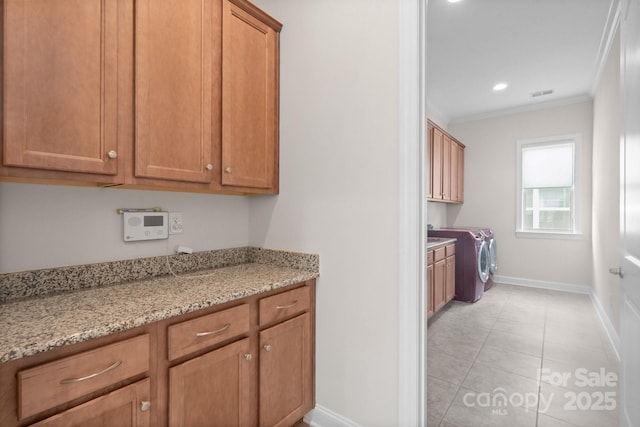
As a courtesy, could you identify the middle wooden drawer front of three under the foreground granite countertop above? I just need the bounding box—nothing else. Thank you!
[168,304,249,360]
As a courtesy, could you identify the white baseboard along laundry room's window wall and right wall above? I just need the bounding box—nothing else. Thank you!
[493,276,620,360]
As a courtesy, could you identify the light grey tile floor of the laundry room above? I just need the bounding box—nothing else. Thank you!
[427,284,619,427]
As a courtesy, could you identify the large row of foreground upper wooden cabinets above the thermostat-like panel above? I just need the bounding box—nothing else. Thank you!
[0,0,282,194]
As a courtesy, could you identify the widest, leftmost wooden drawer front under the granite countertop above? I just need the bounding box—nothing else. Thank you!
[18,334,149,419]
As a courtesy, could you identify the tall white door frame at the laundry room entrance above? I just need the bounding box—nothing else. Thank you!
[398,0,428,426]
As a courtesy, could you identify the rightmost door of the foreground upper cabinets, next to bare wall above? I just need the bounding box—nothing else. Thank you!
[221,0,281,192]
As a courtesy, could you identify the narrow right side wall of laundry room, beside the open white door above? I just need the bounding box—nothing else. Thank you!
[593,30,622,333]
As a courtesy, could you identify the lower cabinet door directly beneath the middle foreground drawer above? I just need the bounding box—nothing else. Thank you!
[169,338,254,427]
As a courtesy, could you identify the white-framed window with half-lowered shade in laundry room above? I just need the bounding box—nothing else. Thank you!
[516,134,581,237]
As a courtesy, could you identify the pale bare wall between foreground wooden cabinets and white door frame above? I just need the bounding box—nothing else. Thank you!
[250,0,399,426]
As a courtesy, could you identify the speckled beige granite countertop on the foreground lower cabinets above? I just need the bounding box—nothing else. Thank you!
[0,248,319,362]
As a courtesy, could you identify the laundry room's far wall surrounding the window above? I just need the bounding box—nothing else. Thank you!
[448,102,593,286]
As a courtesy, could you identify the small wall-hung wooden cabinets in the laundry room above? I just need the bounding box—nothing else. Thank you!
[427,121,464,203]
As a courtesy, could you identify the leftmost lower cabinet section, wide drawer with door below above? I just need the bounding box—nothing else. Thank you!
[0,327,155,427]
